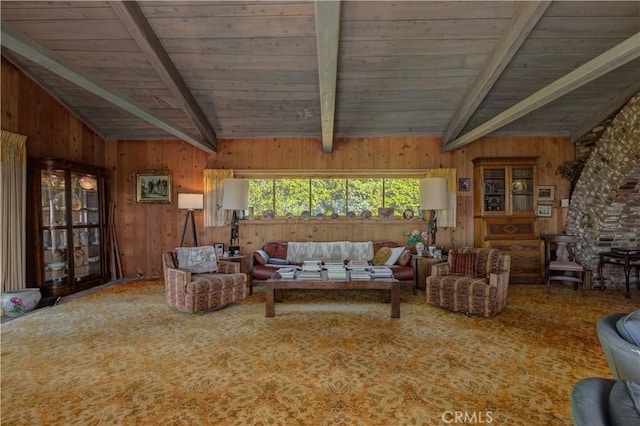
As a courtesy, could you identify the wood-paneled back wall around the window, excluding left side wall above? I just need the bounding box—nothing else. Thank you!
[106,137,573,275]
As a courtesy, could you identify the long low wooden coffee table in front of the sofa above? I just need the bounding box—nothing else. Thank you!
[265,271,400,318]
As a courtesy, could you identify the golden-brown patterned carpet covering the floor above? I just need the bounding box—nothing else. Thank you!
[0,280,640,426]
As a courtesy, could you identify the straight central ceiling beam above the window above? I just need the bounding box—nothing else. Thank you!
[315,0,340,153]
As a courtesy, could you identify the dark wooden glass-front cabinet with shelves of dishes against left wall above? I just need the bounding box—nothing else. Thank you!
[27,158,107,296]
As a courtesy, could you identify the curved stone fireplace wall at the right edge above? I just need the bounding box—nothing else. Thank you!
[566,93,640,290]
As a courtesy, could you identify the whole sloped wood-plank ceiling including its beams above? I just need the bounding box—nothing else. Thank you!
[0,0,640,152]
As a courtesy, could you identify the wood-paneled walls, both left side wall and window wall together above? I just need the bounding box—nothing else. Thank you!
[2,58,574,276]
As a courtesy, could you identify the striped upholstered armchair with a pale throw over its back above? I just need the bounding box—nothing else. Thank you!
[162,246,247,314]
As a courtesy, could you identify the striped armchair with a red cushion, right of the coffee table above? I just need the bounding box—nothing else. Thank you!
[427,247,511,317]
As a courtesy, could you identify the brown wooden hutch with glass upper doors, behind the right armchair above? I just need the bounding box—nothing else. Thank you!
[473,157,544,284]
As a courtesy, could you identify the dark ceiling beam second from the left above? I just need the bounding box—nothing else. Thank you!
[109,1,218,151]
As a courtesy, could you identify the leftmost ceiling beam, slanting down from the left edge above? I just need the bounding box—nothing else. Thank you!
[1,22,215,154]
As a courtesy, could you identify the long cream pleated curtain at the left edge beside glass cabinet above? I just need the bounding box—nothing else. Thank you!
[0,130,27,292]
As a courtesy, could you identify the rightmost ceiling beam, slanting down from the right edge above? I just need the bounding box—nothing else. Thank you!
[444,32,640,152]
